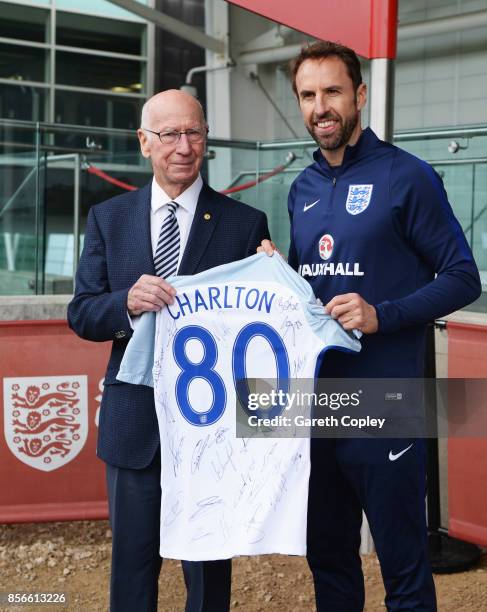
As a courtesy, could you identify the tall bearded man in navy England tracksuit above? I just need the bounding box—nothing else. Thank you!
[263,42,481,612]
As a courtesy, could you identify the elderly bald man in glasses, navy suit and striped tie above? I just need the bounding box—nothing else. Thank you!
[68,90,269,612]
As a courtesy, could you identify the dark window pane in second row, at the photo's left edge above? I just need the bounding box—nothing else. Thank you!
[0,43,47,82]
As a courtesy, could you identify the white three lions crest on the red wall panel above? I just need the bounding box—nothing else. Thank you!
[3,376,88,472]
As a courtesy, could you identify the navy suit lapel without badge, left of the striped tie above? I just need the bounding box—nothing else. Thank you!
[129,183,155,275]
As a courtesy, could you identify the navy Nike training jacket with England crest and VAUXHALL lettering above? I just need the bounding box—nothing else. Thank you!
[288,128,481,377]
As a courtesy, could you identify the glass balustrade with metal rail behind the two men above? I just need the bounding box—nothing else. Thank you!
[0,119,487,294]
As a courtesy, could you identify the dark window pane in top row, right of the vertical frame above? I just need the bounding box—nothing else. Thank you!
[56,11,145,55]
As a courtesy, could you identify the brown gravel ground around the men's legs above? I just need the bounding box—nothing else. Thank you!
[0,521,487,612]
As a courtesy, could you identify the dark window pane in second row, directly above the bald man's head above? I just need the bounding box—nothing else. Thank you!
[56,51,142,93]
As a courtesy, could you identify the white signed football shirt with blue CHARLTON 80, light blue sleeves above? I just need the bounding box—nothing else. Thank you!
[117,254,360,561]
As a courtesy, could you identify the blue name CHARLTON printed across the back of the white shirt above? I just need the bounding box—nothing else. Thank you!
[167,285,276,319]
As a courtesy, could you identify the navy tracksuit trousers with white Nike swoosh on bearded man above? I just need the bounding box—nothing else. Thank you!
[307,439,436,612]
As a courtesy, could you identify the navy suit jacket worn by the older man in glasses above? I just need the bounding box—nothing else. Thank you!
[68,184,269,469]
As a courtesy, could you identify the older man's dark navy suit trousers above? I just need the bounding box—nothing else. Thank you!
[106,452,231,612]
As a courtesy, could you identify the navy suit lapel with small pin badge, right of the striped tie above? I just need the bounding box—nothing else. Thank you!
[178,183,222,275]
